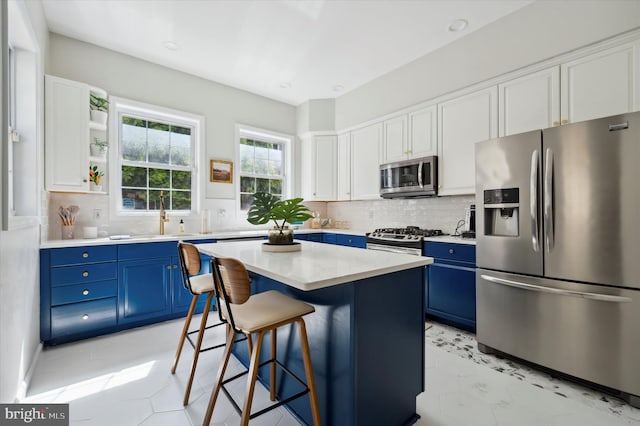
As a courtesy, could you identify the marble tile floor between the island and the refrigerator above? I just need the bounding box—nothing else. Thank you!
[417,323,640,426]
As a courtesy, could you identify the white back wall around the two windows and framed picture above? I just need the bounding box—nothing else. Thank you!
[49,33,298,235]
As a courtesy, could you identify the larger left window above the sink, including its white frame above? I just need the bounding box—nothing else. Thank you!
[111,98,201,214]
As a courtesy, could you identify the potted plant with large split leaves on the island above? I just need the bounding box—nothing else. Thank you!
[247,192,313,245]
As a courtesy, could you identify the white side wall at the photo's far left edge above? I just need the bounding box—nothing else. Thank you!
[0,0,48,402]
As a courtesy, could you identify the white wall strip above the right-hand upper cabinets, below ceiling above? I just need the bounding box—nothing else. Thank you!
[335,0,640,130]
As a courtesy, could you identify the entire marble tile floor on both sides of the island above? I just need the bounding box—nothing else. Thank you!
[24,318,640,426]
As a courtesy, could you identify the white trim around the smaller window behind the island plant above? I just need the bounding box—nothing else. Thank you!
[233,124,294,219]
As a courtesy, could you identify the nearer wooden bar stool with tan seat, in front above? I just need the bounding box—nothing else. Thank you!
[204,257,320,426]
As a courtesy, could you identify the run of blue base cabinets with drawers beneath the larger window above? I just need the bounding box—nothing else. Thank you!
[40,240,215,345]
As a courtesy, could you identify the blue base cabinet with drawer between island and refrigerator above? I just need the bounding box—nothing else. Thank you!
[423,241,476,331]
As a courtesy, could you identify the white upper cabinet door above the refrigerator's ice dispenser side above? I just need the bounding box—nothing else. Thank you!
[498,66,560,136]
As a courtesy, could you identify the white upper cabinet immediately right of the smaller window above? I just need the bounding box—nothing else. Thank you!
[302,135,337,201]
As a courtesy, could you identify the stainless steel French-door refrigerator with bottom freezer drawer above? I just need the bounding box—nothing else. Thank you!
[476,113,640,406]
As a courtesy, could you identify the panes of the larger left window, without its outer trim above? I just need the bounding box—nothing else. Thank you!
[120,115,194,211]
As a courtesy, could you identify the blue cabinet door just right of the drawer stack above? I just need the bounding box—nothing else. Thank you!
[118,258,172,324]
